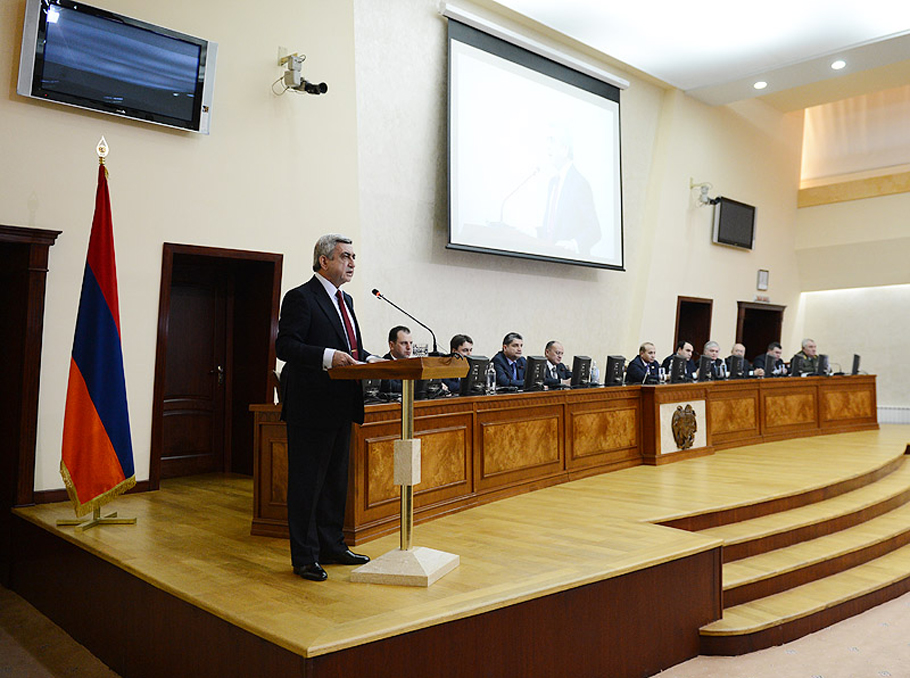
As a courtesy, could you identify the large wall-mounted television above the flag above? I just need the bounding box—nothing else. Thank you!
[16,0,218,134]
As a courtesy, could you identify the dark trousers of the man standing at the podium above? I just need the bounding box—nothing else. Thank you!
[287,423,351,567]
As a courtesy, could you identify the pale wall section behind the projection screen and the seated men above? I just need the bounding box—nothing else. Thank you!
[354,0,802,363]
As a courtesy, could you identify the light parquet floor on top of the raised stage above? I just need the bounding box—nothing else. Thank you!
[17,426,910,656]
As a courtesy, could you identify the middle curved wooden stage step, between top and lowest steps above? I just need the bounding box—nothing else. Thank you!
[723,504,910,607]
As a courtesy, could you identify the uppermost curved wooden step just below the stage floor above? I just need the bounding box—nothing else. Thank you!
[699,457,910,563]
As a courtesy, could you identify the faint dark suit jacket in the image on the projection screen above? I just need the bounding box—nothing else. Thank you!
[541,165,602,254]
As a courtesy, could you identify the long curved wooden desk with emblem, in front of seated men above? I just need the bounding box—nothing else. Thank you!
[250,375,878,544]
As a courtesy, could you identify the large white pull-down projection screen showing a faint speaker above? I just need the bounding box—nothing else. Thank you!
[447,20,623,269]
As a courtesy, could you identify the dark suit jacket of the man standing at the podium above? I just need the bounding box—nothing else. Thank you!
[275,275,370,428]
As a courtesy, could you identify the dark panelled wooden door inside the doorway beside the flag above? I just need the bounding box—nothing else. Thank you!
[161,261,230,478]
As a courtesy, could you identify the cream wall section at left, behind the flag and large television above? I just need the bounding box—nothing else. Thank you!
[0,0,358,490]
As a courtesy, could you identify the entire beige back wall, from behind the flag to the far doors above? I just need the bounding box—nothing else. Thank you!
[0,0,848,489]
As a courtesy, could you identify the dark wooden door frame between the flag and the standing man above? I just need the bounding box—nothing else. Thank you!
[149,242,283,490]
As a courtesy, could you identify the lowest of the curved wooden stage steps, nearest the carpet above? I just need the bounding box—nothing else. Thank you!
[700,546,910,655]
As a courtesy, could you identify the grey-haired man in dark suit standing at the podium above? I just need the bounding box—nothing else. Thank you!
[275,233,381,581]
